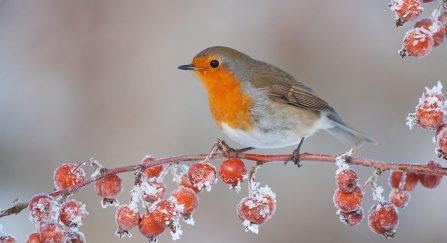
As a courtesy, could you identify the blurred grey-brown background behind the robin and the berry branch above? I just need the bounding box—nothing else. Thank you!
[0,0,447,243]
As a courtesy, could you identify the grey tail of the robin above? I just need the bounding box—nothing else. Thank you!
[326,115,377,148]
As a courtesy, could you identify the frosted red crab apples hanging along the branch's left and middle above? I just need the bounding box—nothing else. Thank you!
[17,152,276,243]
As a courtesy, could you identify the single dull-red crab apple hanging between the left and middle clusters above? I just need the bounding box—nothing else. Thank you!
[95,174,123,199]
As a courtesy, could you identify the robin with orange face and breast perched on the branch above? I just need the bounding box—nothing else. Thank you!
[178,46,377,165]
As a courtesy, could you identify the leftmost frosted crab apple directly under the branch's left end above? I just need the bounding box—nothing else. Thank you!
[28,194,59,225]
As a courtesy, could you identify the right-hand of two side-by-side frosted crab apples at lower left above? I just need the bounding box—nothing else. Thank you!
[59,200,87,228]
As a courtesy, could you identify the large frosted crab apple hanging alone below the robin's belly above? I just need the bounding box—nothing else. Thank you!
[237,197,270,225]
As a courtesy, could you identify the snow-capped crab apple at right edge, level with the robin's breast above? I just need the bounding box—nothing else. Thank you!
[416,90,446,130]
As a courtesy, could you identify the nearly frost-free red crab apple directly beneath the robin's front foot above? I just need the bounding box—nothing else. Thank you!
[219,159,247,185]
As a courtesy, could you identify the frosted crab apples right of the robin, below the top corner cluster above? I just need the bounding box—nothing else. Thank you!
[333,82,447,238]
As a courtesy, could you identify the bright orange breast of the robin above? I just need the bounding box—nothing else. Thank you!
[194,66,253,131]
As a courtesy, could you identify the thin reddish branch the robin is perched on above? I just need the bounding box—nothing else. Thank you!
[0,151,447,218]
